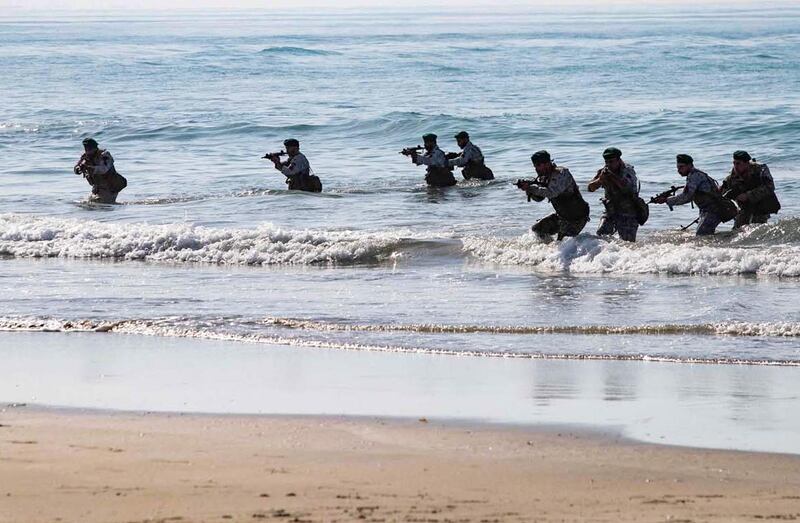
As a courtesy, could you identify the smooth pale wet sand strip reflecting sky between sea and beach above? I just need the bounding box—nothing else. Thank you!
[0,333,800,455]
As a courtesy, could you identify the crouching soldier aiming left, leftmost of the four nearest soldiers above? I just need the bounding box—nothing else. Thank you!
[517,151,589,241]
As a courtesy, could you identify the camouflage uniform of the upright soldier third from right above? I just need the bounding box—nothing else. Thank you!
[597,162,639,242]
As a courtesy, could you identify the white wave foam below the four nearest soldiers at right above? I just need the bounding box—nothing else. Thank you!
[463,233,800,277]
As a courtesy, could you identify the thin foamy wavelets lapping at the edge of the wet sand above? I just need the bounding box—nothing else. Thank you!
[0,318,800,366]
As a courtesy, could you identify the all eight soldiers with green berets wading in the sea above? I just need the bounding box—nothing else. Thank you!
[74,131,780,242]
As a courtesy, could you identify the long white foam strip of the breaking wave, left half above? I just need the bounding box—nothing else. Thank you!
[0,215,410,265]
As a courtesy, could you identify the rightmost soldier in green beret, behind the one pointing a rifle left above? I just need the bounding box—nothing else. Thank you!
[722,151,781,229]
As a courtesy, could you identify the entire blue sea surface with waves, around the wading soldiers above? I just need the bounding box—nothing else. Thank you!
[0,4,800,366]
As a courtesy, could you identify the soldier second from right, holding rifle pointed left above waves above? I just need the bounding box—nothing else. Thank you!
[652,154,730,236]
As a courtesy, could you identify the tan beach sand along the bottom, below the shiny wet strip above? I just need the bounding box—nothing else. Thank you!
[0,406,800,523]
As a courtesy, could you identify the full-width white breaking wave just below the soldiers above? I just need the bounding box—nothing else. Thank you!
[0,215,800,277]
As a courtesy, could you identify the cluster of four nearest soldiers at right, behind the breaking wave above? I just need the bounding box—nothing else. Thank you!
[517,147,780,242]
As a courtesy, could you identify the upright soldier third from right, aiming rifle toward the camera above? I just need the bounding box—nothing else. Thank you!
[588,147,639,242]
